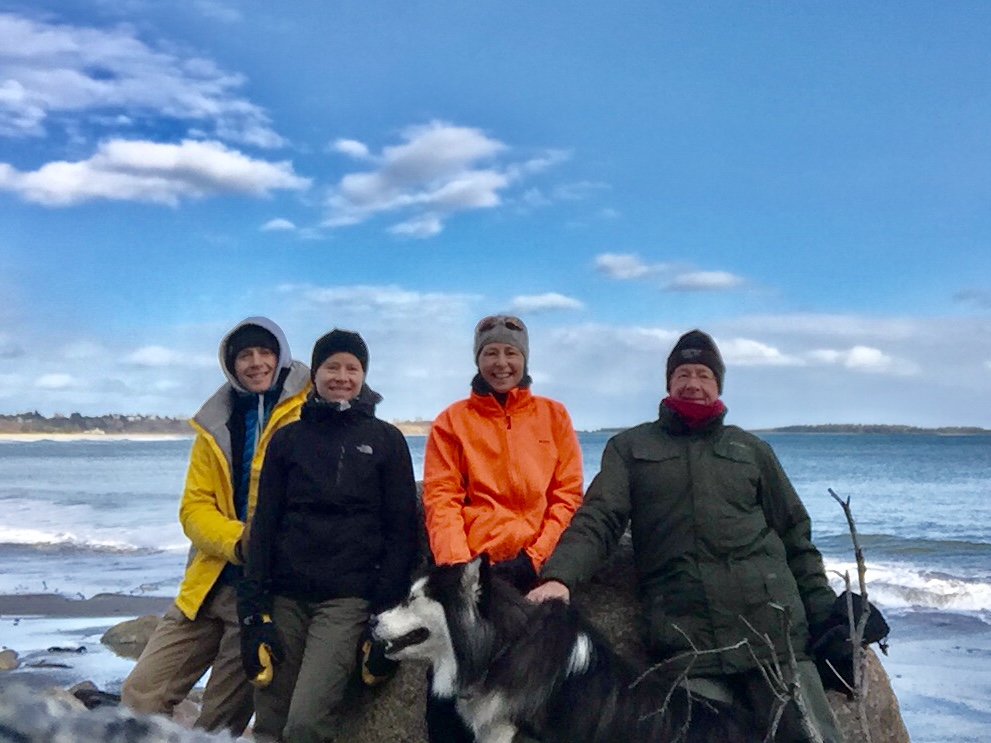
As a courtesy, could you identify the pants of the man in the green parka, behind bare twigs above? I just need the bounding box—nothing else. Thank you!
[683,660,843,743]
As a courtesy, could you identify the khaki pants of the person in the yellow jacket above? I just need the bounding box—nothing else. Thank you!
[121,584,252,736]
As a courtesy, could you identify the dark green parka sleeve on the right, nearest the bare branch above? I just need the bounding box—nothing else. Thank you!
[760,444,836,628]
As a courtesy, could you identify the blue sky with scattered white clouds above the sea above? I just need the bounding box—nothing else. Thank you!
[0,0,991,428]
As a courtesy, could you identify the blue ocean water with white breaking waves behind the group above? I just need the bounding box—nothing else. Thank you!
[0,433,991,741]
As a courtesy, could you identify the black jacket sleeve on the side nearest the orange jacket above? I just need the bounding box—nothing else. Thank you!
[370,426,418,614]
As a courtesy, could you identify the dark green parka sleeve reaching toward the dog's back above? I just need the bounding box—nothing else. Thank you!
[540,437,630,590]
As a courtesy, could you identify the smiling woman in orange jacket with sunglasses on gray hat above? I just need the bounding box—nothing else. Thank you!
[423,315,583,743]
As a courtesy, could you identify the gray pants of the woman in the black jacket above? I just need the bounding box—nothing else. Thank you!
[254,596,368,743]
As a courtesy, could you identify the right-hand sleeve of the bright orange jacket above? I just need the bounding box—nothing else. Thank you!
[526,406,583,573]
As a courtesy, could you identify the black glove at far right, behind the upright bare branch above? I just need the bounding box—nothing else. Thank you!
[809,591,889,694]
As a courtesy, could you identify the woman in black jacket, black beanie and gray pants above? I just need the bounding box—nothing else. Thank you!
[238,329,417,743]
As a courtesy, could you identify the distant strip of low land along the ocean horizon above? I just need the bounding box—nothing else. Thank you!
[0,410,991,436]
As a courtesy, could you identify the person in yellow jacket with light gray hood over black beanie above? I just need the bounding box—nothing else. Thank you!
[121,317,311,736]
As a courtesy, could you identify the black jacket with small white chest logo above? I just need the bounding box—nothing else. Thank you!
[248,386,417,615]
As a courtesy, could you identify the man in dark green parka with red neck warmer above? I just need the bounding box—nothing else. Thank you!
[529,330,842,743]
